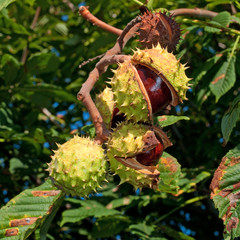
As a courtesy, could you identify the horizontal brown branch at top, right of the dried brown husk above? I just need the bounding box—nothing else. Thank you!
[170,8,218,18]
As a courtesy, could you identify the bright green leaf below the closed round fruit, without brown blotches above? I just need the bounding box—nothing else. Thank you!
[60,200,120,226]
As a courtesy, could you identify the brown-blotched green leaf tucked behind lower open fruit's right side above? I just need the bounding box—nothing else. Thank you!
[158,152,181,193]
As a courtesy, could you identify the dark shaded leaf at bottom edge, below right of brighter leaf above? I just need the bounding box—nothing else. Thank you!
[91,215,131,238]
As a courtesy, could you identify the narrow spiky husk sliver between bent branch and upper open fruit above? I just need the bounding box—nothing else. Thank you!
[95,87,114,129]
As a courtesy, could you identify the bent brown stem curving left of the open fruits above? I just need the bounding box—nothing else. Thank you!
[77,55,129,144]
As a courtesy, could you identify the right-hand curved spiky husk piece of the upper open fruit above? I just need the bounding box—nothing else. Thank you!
[132,44,190,100]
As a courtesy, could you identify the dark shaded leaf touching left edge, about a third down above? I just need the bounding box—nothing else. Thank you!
[1,54,20,85]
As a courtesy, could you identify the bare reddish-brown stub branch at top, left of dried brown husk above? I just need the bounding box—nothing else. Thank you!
[79,6,122,36]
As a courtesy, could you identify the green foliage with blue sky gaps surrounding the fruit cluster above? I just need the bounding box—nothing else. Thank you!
[0,0,240,240]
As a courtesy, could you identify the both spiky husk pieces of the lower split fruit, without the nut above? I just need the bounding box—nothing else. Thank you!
[107,122,158,189]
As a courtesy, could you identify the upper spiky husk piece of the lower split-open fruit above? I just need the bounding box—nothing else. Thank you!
[107,122,151,157]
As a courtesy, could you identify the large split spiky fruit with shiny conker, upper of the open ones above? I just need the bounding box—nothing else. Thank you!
[110,45,190,124]
